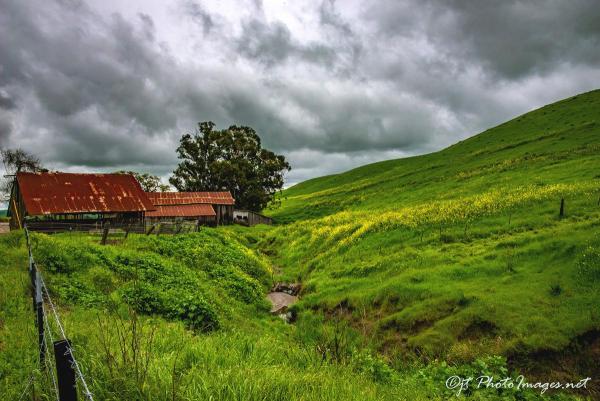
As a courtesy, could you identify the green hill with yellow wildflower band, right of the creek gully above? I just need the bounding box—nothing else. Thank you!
[262,90,600,390]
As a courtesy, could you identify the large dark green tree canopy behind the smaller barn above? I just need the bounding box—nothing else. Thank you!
[169,121,291,211]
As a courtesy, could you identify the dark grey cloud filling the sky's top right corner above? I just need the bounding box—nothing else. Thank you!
[366,0,600,79]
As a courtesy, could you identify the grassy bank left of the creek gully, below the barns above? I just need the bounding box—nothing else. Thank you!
[0,230,436,400]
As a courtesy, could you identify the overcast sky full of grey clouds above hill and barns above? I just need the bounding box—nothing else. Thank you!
[0,0,600,189]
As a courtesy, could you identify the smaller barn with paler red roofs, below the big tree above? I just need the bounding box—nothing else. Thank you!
[146,191,235,225]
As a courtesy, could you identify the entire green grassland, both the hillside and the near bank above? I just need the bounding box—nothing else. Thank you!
[0,91,600,401]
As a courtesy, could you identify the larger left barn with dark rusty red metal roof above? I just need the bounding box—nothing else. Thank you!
[8,172,155,232]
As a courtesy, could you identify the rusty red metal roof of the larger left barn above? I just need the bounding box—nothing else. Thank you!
[17,173,155,216]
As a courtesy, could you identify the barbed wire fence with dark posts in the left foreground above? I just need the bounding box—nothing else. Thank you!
[19,227,94,401]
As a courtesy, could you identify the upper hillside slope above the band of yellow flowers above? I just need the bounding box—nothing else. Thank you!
[269,90,600,223]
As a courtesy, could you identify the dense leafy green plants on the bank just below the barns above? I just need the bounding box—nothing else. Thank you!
[33,230,270,331]
